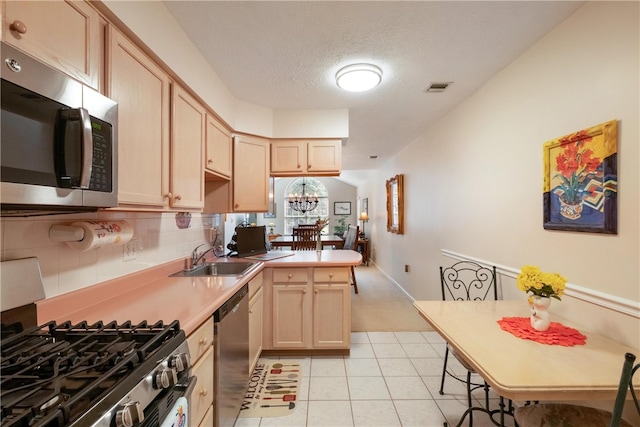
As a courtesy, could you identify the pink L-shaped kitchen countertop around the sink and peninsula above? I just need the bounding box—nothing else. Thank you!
[36,250,362,335]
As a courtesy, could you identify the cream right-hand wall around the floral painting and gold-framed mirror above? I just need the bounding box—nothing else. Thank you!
[370,2,640,345]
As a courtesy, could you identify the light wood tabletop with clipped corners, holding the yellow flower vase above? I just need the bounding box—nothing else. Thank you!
[414,300,640,407]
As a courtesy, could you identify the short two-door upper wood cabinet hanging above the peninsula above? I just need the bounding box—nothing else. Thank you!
[271,139,342,176]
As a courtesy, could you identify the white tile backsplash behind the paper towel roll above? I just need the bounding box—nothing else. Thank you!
[0,211,224,298]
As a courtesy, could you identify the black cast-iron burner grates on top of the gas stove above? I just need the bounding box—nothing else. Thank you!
[0,321,184,427]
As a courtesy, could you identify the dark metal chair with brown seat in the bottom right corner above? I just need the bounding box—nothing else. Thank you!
[515,353,640,427]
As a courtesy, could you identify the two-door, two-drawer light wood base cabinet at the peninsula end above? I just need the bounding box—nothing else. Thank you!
[263,267,351,350]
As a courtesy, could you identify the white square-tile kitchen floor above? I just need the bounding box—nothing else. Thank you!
[235,332,513,427]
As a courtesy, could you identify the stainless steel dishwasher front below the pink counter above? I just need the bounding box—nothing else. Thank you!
[213,284,249,427]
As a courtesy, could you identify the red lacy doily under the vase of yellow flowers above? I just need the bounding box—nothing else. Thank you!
[498,317,587,347]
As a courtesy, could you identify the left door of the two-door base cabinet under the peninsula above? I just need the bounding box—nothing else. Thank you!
[272,284,311,349]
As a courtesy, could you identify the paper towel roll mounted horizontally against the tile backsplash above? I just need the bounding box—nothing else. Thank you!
[67,220,133,252]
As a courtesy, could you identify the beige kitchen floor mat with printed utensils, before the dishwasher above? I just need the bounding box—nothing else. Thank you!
[238,360,302,418]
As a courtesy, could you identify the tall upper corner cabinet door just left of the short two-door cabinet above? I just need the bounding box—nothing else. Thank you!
[233,136,270,212]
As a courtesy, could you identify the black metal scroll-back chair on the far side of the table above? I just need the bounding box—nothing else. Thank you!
[439,261,502,426]
